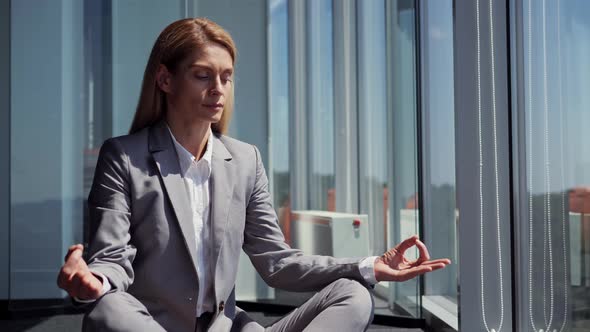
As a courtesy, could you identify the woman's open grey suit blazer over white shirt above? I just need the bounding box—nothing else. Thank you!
[88,122,364,331]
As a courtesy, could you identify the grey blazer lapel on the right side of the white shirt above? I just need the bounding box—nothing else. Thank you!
[210,135,235,271]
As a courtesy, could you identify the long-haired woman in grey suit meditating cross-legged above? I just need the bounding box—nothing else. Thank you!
[58,18,449,331]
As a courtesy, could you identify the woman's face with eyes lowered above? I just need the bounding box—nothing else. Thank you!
[164,43,233,124]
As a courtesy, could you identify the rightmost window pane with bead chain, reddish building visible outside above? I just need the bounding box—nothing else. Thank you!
[520,0,590,332]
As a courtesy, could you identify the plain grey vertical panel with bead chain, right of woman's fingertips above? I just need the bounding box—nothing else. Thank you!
[453,0,519,331]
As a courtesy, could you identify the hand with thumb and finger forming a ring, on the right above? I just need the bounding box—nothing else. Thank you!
[375,235,451,281]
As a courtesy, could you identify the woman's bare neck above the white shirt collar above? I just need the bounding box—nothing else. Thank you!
[166,116,211,160]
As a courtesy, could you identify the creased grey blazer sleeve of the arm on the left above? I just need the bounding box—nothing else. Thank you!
[88,138,137,291]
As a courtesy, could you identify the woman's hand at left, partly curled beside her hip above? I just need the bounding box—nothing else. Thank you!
[57,244,102,300]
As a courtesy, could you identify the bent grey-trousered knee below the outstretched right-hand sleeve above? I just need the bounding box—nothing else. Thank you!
[333,279,375,325]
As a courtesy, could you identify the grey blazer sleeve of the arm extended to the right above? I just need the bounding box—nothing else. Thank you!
[243,147,370,292]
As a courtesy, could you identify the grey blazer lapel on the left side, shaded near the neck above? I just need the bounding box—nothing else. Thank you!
[149,121,197,274]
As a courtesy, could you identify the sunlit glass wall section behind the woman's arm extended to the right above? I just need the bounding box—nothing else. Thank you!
[265,1,426,317]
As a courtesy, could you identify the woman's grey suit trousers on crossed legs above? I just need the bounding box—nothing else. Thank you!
[82,279,374,332]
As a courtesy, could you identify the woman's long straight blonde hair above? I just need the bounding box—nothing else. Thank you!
[129,18,237,134]
